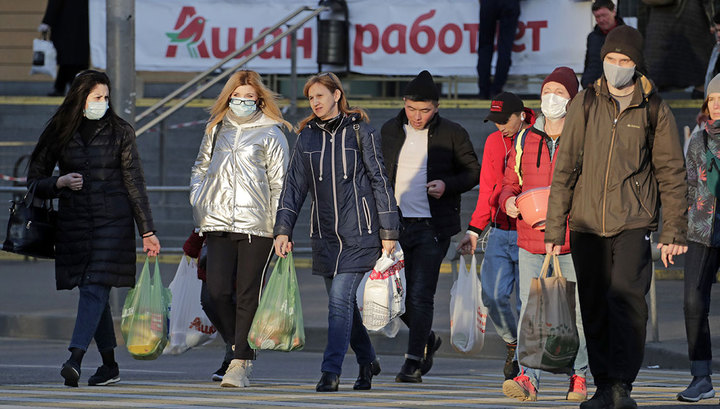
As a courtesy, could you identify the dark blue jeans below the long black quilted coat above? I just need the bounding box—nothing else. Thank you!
[70,284,117,351]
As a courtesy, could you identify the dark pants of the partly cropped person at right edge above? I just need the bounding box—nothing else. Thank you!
[683,241,720,376]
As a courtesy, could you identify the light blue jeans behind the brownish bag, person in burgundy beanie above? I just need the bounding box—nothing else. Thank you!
[519,249,588,389]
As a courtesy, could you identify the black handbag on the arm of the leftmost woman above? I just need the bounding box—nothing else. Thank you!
[3,183,57,258]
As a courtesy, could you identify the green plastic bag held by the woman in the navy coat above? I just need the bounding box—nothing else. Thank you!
[248,252,305,352]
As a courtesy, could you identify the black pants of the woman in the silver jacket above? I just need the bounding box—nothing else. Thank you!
[207,233,273,359]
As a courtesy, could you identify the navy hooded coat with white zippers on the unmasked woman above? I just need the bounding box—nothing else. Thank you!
[274,115,399,277]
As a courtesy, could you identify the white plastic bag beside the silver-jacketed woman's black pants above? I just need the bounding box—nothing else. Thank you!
[163,256,217,355]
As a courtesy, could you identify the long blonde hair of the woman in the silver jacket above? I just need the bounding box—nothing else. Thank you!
[205,70,292,133]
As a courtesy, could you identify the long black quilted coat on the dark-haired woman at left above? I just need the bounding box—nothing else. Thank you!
[28,115,155,290]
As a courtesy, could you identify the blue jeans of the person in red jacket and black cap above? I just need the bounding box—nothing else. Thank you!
[480,227,521,344]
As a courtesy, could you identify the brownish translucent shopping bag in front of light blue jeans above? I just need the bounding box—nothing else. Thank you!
[518,254,580,375]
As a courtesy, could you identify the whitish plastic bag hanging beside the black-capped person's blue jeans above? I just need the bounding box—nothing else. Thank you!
[450,255,488,354]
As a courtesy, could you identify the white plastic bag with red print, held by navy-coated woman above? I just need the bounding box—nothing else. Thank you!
[358,246,405,336]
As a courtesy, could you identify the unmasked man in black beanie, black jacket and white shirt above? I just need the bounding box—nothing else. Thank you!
[381,71,480,382]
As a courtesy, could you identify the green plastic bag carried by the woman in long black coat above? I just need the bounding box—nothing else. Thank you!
[120,257,172,360]
